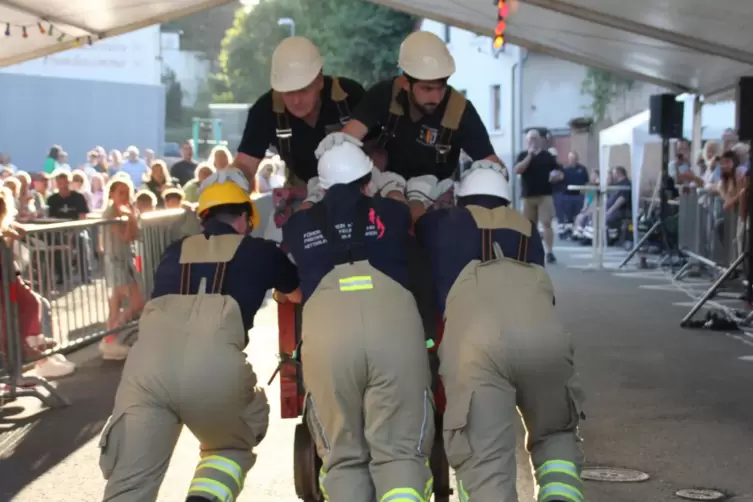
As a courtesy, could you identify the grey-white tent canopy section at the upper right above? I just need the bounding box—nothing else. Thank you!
[372,0,753,95]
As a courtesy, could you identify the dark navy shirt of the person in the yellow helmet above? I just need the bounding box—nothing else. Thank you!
[152,220,299,343]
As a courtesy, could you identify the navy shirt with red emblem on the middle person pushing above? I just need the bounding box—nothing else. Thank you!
[282,185,411,301]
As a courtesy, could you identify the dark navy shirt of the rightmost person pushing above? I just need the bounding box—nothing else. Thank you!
[416,197,545,312]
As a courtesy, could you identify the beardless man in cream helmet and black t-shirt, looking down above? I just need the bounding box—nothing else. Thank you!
[235,37,364,191]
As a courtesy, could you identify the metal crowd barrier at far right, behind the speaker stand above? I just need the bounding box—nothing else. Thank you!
[674,187,747,326]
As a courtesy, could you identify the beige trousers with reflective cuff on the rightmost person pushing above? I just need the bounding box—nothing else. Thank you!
[439,259,584,502]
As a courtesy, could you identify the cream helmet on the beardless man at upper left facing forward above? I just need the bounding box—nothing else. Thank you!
[270,37,324,92]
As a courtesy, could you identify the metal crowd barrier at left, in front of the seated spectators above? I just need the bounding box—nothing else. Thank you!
[0,209,199,408]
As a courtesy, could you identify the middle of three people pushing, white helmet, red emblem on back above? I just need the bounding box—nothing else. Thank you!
[283,142,434,502]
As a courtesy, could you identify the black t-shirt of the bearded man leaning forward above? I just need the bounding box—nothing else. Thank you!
[353,79,494,179]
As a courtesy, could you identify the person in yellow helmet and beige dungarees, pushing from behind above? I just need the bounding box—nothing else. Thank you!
[100,168,300,502]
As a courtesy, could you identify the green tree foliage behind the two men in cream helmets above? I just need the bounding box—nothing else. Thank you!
[213,0,416,103]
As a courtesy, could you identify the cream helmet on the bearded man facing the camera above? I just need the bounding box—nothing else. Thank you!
[397,31,455,80]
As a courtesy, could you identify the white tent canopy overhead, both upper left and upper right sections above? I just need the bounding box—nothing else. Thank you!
[0,0,753,95]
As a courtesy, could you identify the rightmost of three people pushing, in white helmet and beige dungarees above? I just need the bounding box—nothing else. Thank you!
[416,161,584,502]
